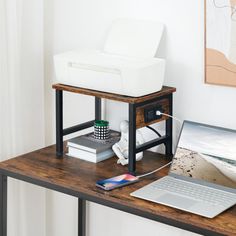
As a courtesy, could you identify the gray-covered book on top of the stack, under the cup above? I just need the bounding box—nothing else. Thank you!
[67,130,120,153]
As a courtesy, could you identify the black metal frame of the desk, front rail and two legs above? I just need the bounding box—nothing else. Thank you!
[0,170,223,236]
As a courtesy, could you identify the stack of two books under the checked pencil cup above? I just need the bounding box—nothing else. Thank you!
[67,130,120,163]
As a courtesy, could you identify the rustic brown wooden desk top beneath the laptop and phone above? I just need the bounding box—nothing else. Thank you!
[0,146,236,235]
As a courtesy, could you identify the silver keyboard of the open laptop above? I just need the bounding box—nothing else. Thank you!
[150,177,235,206]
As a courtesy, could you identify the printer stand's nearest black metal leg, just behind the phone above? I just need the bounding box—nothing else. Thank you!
[129,104,136,174]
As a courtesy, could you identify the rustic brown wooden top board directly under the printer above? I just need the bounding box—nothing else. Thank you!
[52,84,176,104]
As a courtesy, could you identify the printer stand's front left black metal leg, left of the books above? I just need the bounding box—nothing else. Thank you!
[56,90,63,157]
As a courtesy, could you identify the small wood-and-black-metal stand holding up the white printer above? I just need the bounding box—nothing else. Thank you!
[52,84,176,174]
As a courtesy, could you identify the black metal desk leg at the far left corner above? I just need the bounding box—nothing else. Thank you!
[0,175,7,236]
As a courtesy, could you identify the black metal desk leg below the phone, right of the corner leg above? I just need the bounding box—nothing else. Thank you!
[78,198,86,236]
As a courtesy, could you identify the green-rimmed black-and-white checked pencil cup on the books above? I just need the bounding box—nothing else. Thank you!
[94,120,110,140]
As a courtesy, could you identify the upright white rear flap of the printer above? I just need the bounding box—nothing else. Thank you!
[104,18,164,57]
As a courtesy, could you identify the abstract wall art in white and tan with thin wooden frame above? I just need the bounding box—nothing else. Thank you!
[205,0,236,86]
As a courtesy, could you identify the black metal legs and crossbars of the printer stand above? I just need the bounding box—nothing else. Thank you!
[56,89,173,174]
